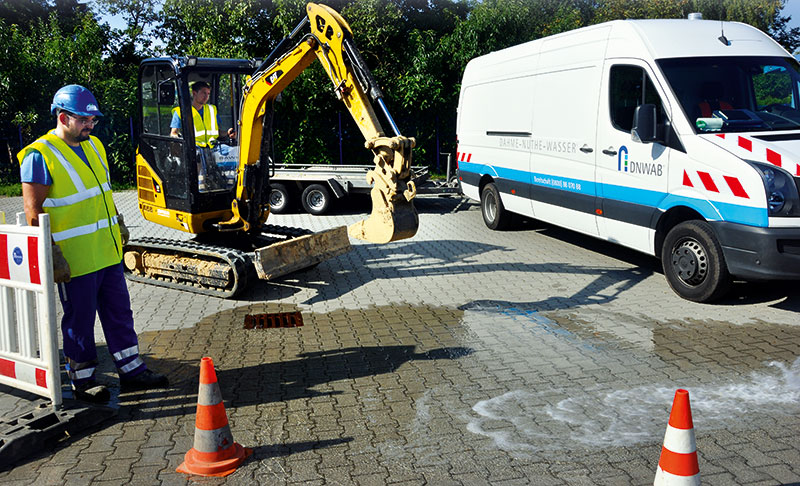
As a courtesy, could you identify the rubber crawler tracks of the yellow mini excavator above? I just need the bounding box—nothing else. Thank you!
[124,225,311,298]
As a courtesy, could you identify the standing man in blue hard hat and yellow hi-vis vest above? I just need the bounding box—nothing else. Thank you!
[17,84,169,403]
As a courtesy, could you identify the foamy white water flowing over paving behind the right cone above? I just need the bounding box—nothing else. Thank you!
[467,358,800,452]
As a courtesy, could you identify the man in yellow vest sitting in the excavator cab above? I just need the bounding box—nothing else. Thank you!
[169,81,236,192]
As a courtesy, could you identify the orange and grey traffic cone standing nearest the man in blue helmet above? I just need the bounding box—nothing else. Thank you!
[177,358,253,477]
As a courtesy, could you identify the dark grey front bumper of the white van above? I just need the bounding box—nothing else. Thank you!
[710,221,800,280]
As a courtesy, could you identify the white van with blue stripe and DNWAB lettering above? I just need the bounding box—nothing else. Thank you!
[457,15,800,302]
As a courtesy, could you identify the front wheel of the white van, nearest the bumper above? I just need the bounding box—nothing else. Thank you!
[661,221,731,302]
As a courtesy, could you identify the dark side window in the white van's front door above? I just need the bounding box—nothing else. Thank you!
[609,65,665,133]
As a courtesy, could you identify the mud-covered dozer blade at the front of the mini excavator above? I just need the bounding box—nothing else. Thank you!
[253,226,351,280]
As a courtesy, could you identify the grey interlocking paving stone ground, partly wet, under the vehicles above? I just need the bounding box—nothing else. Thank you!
[0,192,800,486]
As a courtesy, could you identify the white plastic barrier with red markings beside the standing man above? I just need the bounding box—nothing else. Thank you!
[0,212,61,408]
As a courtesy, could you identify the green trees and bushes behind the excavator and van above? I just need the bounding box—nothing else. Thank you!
[0,0,800,185]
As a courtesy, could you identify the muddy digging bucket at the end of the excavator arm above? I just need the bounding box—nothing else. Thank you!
[348,136,419,243]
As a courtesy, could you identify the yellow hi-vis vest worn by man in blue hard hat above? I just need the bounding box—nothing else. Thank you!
[17,130,122,277]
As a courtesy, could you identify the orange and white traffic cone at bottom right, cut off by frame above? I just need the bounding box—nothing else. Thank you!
[653,389,700,486]
